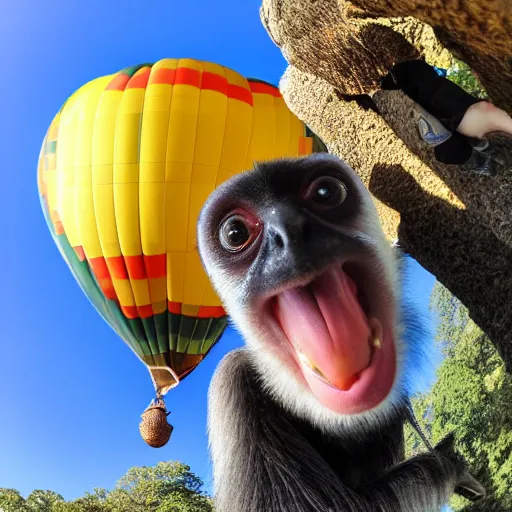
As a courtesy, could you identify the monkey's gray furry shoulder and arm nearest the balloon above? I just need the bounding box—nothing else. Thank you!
[208,349,367,512]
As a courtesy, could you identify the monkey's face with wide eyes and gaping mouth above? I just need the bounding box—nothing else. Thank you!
[198,155,397,414]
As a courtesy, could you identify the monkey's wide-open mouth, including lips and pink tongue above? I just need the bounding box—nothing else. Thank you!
[269,264,396,414]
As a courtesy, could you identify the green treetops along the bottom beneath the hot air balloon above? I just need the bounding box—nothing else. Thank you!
[0,461,213,512]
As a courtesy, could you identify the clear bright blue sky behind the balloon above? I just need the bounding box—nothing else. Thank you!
[0,0,434,499]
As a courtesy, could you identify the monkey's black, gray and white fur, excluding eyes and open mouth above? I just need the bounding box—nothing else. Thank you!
[198,155,480,512]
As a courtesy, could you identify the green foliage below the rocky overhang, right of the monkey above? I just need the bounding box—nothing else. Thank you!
[406,284,512,512]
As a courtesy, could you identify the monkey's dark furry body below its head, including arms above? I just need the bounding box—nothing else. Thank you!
[209,349,464,512]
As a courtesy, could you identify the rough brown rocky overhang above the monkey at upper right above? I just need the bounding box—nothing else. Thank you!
[261,0,512,372]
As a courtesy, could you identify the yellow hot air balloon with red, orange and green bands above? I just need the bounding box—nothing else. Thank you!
[38,59,313,445]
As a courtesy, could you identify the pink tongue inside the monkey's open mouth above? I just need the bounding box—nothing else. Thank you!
[275,268,371,391]
